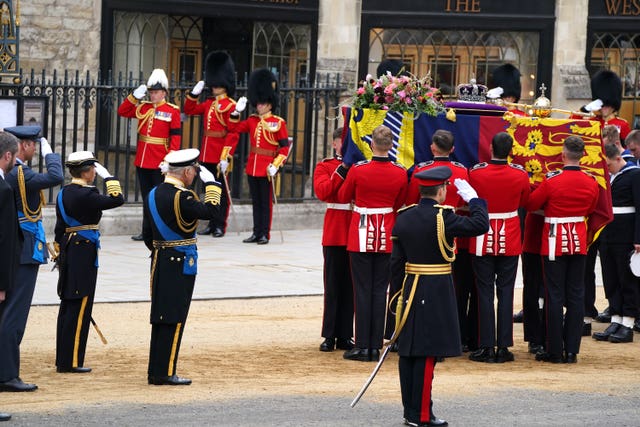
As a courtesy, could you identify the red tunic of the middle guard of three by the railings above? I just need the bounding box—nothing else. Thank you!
[184,94,239,163]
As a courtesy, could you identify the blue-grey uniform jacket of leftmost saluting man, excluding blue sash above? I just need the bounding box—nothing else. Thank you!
[7,153,64,264]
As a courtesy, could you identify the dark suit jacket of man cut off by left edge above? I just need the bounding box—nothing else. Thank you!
[0,177,23,291]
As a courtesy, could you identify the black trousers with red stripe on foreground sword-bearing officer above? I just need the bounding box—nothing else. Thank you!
[398,356,436,424]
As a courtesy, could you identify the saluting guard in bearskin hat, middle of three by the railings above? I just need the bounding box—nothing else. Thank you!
[184,51,238,237]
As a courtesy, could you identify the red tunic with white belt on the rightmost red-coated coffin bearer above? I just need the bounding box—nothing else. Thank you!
[527,166,599,260]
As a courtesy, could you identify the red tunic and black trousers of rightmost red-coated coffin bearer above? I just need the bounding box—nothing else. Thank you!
[527,166,599,356]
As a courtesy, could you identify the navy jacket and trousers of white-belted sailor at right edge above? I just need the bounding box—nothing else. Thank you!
[599,163,640,318]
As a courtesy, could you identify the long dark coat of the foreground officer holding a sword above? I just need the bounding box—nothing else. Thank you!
[391,198,489,357]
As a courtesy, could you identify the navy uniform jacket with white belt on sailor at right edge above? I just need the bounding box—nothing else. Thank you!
[600,163,640,245]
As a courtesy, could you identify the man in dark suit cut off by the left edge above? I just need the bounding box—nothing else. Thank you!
[0,132,22,421]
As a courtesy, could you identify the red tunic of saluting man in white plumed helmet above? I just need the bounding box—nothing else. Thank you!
[118,95,182,169]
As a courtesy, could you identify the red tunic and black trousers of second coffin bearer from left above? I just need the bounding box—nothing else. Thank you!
[332,156,407,349]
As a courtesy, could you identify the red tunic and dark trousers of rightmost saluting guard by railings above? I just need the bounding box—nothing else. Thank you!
[228,113,291,239]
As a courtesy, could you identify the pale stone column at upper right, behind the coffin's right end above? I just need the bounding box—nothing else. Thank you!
[551,0,591,117]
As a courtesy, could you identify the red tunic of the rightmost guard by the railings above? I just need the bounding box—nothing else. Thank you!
[228,113,290,177]
